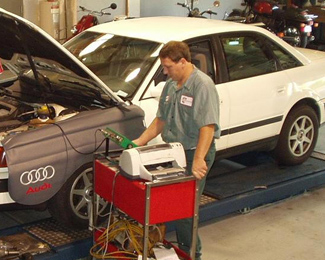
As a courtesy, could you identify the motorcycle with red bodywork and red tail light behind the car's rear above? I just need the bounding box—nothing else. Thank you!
[226,0,318,48]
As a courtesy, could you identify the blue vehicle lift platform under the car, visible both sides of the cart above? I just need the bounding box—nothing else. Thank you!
[0,152,325,260]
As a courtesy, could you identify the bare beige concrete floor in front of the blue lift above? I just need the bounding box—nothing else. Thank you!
[168,127,325,260]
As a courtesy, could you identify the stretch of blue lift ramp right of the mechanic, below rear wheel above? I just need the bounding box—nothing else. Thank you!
[200,152,325,222]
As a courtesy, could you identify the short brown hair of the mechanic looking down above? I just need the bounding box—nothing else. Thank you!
[159,41,191,62]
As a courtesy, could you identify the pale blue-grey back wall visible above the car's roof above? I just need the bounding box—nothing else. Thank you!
[140,0,244,19]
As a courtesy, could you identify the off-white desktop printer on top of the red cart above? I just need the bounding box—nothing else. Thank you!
[119,143,186,181]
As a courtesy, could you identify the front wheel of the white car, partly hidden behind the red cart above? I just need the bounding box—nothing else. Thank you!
[48,163,108,228]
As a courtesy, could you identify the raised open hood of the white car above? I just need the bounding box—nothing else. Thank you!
[0,8,123,103]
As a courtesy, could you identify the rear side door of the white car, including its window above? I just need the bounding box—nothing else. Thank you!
[219,32,293,147]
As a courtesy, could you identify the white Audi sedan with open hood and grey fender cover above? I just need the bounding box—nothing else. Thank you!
[0,10,325,228]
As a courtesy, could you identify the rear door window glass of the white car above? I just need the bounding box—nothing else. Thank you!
[220,35,277,80]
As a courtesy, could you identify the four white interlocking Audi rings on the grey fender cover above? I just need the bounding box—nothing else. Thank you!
[20,165,55,185]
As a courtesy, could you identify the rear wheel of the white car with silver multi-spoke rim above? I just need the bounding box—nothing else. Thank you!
[274,105,319,165]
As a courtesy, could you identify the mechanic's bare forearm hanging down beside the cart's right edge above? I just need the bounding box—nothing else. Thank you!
[192,125,215,180]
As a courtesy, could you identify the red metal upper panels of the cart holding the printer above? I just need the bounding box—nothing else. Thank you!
[94,160,196,225]
